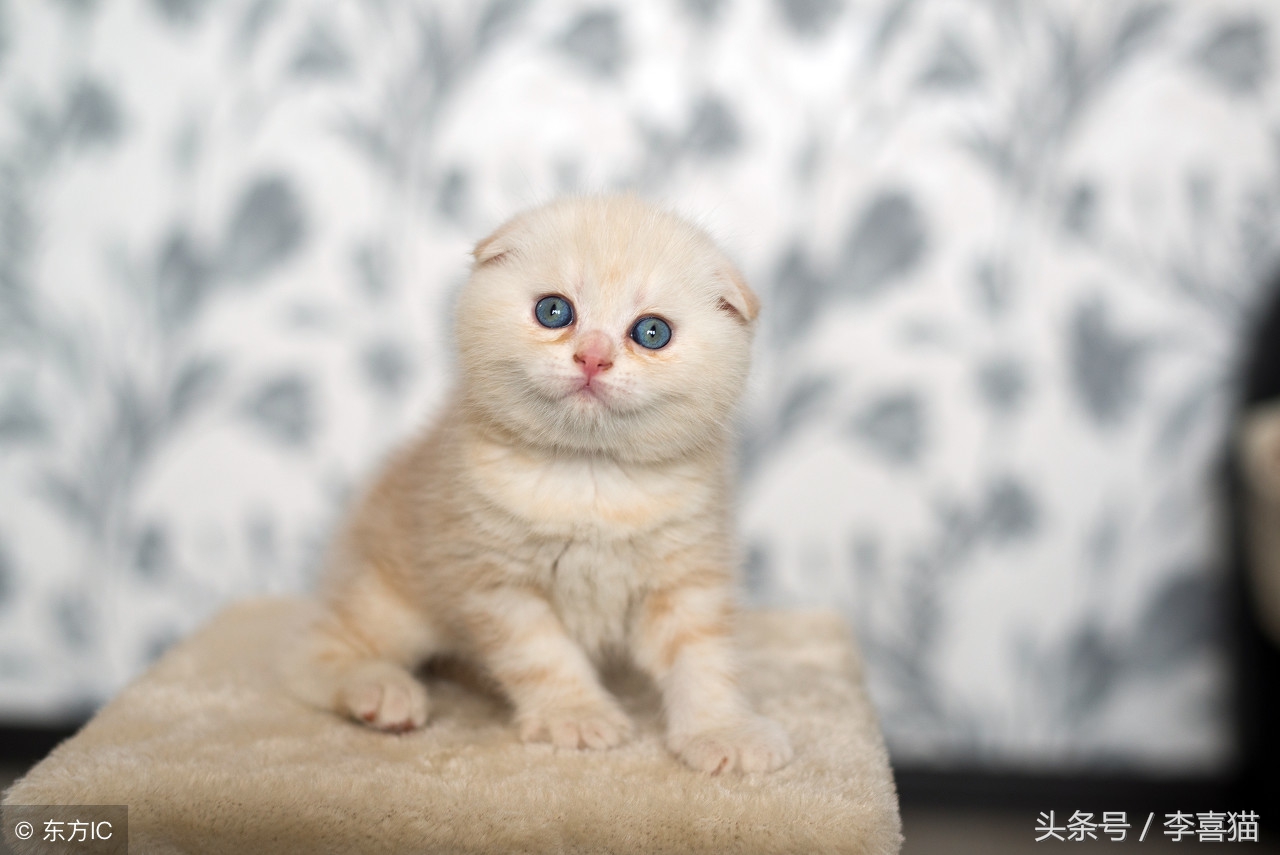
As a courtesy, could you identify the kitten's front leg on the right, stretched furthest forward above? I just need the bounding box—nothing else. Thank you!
[634,585,791,774]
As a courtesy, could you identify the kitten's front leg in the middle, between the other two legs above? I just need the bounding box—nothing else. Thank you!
[463,587,631,749]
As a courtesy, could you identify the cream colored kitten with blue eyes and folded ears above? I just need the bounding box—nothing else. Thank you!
[291,197,791,773]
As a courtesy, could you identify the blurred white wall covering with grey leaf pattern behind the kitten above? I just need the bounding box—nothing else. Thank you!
[0,0,1280,851]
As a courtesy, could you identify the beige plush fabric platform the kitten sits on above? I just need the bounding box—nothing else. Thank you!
[5,599,901,854]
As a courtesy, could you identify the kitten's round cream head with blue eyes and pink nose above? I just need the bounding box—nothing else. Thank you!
[457,197,759,459]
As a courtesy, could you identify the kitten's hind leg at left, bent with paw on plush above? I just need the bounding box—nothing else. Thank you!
[285,573,435,732]
